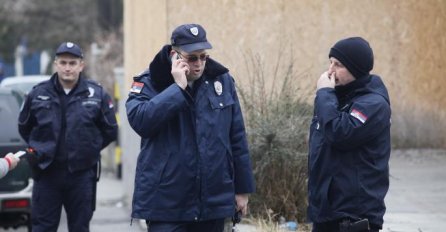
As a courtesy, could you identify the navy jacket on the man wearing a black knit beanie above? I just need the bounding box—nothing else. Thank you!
[308,75,391,226]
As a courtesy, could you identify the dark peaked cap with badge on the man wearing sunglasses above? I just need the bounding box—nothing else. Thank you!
[170,24,212,53]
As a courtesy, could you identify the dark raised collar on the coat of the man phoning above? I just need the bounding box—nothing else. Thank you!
[148,45,229,91]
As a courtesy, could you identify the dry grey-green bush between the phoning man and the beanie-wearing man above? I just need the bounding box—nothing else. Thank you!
[238,52,312,221]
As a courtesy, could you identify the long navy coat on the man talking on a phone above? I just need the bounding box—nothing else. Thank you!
[126,45,254,221]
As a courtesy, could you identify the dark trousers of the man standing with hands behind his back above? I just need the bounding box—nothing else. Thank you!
[31,165,96,232]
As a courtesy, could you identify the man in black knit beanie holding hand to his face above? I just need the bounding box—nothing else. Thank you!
[308,37,391,232]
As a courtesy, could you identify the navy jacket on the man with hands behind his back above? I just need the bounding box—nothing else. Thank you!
[19,73,118,172]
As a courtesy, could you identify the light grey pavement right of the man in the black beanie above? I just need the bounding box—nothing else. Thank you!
[383,149,446,232]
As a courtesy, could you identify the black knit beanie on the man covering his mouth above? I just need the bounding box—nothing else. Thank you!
[328,37,373,79]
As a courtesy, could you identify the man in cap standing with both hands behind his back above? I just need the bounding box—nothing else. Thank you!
[19,42,117,232]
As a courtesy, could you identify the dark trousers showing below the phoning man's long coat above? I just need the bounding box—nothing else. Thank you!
[146,218,225,232]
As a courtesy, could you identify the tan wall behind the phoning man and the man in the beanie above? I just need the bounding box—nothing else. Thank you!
[124,0,446,205]
